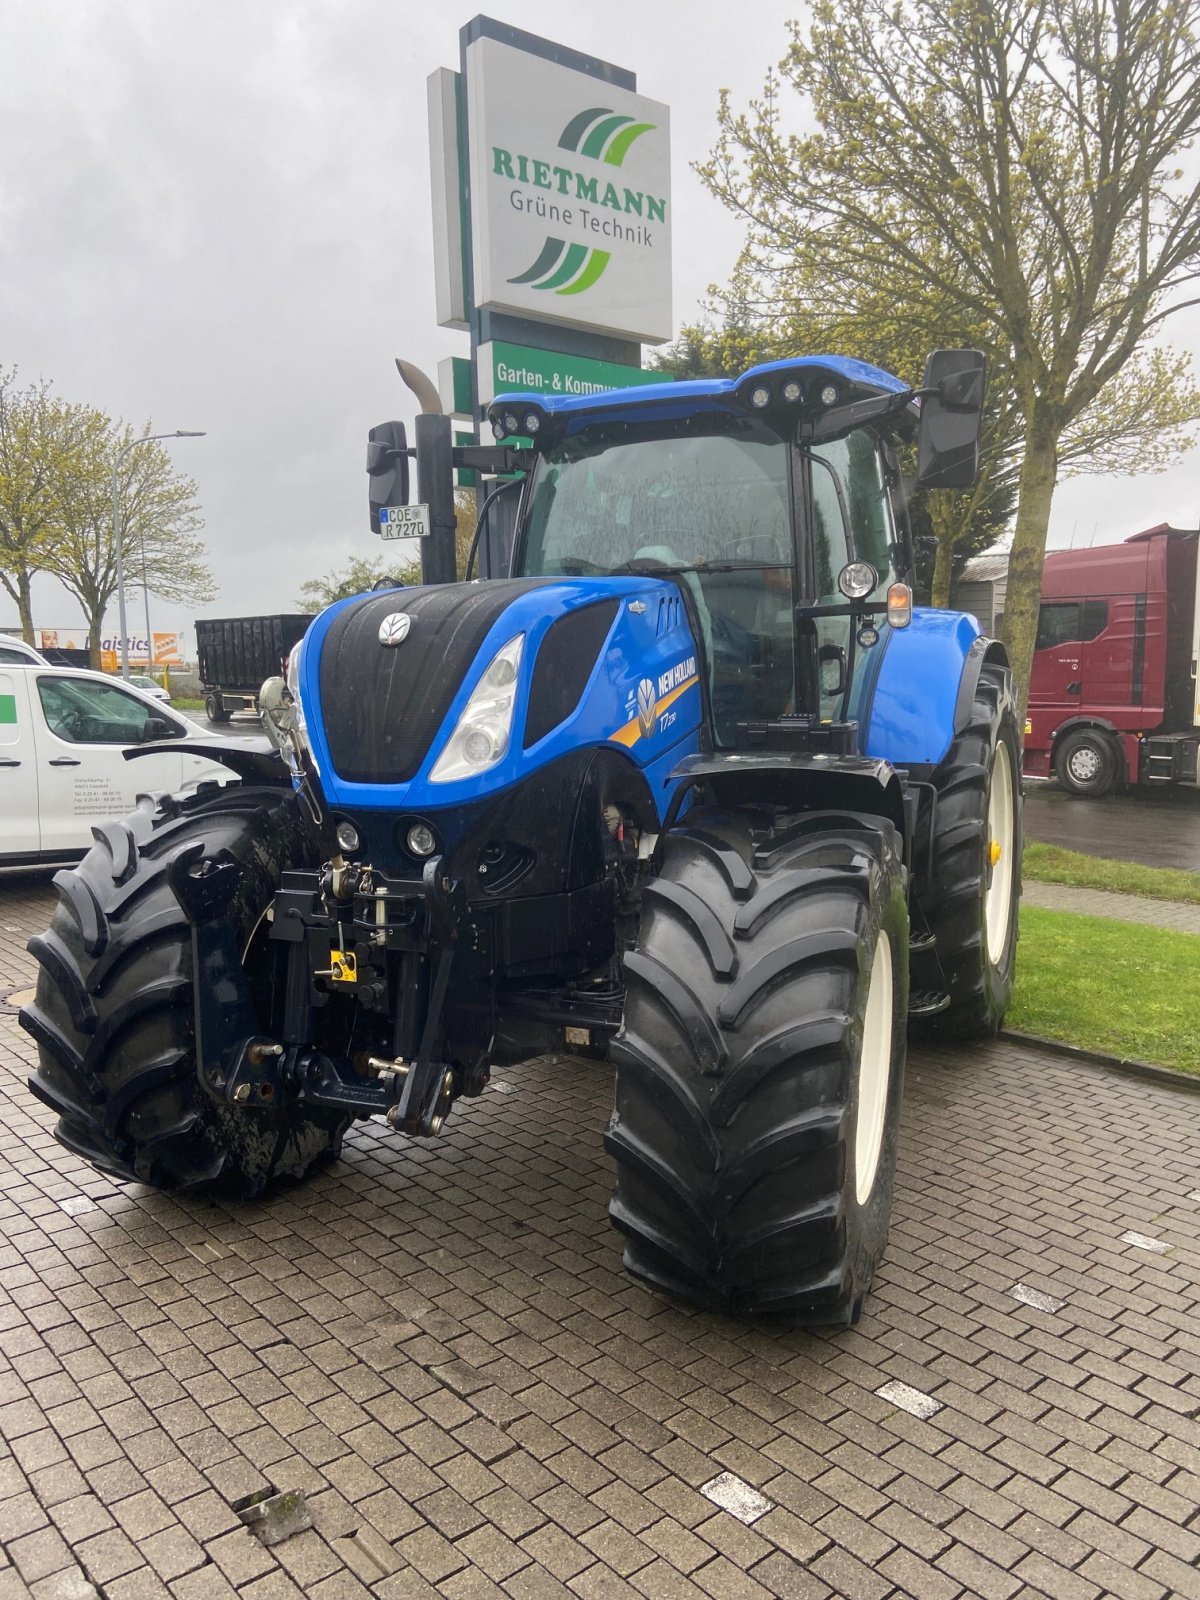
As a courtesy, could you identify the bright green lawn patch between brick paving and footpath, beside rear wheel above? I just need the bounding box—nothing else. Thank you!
[1005,915,1200,1072]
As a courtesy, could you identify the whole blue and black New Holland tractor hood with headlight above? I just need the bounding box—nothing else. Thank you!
[298,576,701,808]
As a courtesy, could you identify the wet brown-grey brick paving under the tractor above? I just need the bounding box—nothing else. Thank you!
[0,877,1200,1600]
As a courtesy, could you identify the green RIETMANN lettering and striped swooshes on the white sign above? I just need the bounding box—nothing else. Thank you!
[505,106,666,294]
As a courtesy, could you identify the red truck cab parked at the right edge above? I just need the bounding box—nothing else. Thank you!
[1024,523,1200,795]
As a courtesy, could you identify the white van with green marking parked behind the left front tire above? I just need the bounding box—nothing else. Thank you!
[0,662,234,867]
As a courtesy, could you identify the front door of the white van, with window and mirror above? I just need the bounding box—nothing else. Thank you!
[27,672,186,853]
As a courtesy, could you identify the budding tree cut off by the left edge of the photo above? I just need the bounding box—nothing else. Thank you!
[0,368,77,645]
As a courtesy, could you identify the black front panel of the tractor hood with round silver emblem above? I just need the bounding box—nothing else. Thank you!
[320,578,552,784]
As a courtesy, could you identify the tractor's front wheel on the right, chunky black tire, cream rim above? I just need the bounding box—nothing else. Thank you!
[605,810,909,1326]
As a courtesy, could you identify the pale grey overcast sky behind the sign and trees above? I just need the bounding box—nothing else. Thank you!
[0,0,1200,643]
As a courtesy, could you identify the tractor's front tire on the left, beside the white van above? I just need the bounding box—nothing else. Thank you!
[21,784,347,1197]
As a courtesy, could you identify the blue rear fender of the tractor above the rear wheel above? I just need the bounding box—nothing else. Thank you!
[862,606,1008,766]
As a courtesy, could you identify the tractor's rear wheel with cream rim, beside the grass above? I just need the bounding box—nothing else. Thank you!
[918,664,1021,1038]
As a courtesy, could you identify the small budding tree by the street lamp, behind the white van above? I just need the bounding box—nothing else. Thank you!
[43,419,216,666]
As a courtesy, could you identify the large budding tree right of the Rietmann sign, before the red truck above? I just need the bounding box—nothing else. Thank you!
[702,0,1200,701]
